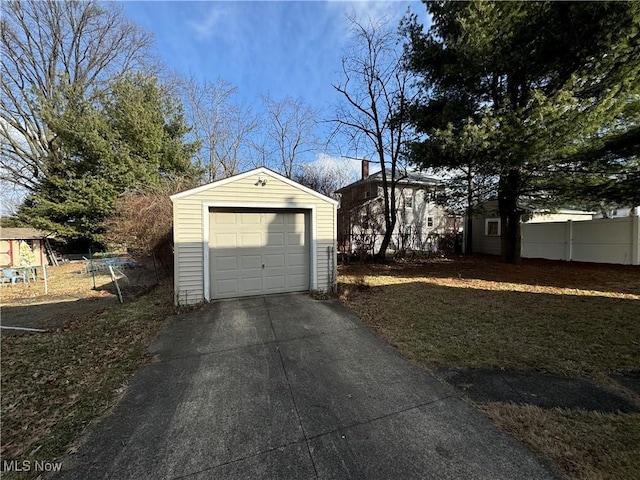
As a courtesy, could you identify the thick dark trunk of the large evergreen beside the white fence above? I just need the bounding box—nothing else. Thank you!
[498,170,522,265]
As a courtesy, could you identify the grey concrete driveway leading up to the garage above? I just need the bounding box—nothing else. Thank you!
[59,294,558,480]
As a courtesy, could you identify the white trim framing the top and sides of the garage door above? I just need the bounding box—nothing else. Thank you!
[202,202,318,302]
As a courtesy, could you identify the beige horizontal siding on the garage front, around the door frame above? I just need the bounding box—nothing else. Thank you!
[172,169,336,304]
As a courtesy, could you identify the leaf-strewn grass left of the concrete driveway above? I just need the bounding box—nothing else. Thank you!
[1,285,174,478]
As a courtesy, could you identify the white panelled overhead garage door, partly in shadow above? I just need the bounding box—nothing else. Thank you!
[209,209,309,299]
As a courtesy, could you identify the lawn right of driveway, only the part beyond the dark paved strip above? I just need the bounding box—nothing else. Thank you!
[340,259,640,378]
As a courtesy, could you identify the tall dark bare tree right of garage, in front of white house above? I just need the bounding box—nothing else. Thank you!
[333,16,412,257]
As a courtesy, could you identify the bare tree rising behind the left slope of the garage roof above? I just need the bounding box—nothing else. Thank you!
[182,78,258,182]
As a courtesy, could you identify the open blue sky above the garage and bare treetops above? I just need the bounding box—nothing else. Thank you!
[123,0,425,168]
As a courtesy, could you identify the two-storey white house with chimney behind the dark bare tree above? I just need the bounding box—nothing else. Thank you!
[336,160,452,253]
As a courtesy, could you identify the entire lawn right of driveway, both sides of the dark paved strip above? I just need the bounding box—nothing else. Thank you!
[339,257,640,479]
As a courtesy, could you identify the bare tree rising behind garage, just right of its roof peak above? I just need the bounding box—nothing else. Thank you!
[258,96,319,178]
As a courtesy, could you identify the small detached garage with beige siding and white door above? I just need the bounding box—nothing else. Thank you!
[171,167,337,305]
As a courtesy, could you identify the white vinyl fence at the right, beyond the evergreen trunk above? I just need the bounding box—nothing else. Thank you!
[522,215,640,265]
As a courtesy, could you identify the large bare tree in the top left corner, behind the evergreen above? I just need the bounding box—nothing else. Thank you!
[0,0,151,190]
